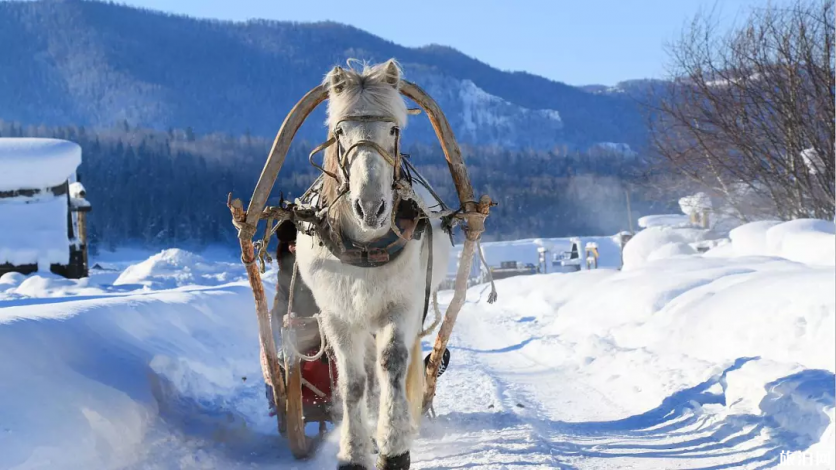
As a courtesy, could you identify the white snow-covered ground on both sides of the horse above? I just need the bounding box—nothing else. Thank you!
[0,221,836,470]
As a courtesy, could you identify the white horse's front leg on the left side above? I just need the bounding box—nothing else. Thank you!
[324,316,372,470]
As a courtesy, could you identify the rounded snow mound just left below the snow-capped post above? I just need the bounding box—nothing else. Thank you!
[622,226,707,270]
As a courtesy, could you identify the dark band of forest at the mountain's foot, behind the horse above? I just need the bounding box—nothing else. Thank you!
[0,121,668,247]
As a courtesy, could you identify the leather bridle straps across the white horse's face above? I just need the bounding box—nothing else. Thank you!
[308,114,401,195]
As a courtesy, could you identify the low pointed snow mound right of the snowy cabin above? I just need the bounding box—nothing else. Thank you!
[113,248,241,289]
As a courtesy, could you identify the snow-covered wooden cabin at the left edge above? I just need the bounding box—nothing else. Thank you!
[0,138,91,279]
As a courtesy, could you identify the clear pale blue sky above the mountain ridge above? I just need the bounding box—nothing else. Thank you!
[116,0,787,85]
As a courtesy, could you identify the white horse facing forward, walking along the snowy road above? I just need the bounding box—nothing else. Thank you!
[296,60,451,469]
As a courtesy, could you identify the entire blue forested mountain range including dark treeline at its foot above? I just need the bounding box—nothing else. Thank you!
[0,0,672,246]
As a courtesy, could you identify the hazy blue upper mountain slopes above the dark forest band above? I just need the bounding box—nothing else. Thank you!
[0,0,646,150]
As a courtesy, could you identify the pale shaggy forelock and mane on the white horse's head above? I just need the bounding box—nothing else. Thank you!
[322,60,407,204]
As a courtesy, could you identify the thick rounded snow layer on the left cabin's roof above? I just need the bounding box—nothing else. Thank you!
[0,138,81,191]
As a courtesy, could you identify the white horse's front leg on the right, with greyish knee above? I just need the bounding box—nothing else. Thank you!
[377,309,417,470]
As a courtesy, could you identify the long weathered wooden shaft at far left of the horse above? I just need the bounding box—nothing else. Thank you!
[229,199,287,432]
